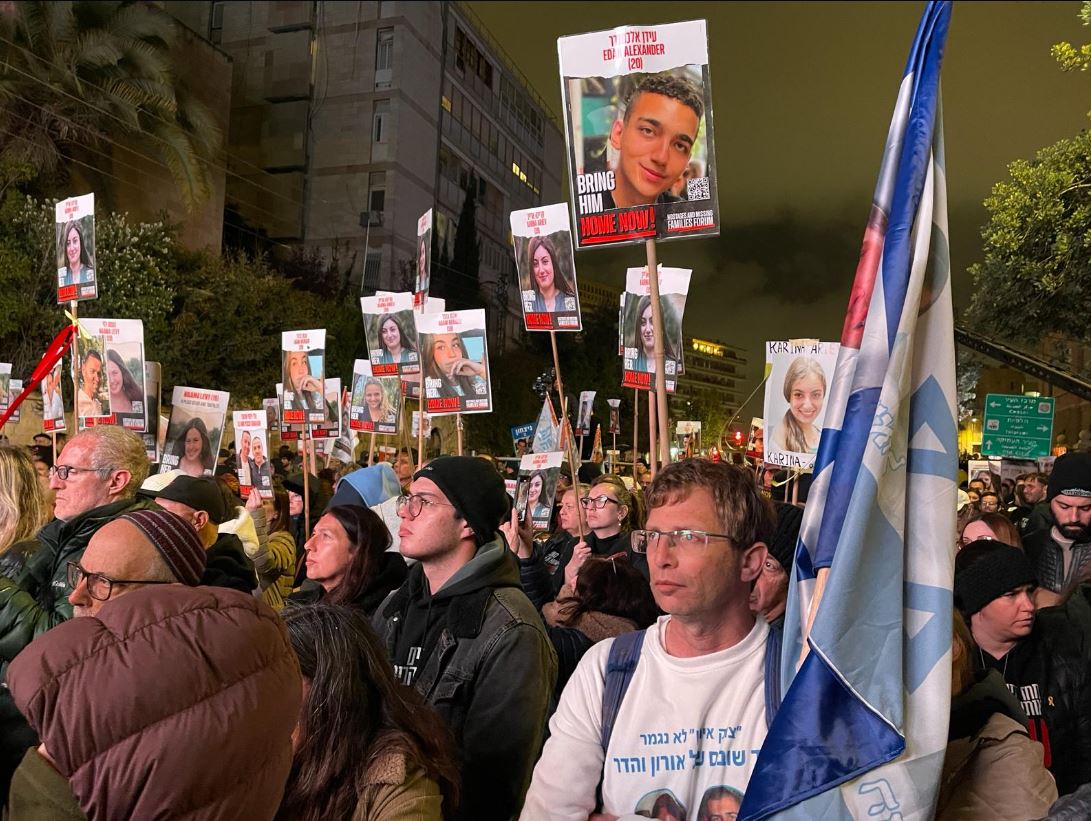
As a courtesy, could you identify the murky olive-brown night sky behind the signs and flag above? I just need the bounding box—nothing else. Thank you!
[468,0,1091,401]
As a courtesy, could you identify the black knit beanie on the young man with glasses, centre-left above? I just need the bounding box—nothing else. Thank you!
[413,456,512,547]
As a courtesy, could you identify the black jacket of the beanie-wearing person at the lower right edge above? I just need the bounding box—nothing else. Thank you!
[974,607,1091,795]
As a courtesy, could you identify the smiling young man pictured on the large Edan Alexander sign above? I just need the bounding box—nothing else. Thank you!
[602,74,705,209]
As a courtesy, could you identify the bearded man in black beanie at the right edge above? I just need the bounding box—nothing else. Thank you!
[1023,452,1091,595]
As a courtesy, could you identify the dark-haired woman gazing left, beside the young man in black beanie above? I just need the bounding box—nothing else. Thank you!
[288,505,409,618]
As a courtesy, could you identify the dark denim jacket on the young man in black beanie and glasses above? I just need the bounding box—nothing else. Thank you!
[372,536,556,821]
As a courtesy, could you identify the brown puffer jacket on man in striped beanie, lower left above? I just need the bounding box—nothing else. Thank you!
[8,584,302,821]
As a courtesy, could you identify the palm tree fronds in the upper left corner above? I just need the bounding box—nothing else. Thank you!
[0,1,221,208]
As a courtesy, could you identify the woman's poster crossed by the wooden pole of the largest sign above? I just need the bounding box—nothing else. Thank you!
[619,265,693,394]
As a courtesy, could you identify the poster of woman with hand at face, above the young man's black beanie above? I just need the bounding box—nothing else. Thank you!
[417,309,492,414]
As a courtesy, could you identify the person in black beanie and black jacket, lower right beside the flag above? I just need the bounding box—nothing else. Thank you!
[955,539,1091,795]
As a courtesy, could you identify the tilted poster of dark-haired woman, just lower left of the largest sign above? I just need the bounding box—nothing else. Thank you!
[511,203,583,330]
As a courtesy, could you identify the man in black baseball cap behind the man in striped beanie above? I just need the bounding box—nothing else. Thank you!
[141,473,257,593]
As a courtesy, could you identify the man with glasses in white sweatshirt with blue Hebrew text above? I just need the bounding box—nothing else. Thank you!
[520,459,776,821]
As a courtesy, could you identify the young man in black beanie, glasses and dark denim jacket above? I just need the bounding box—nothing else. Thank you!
[372,456,556,819]
